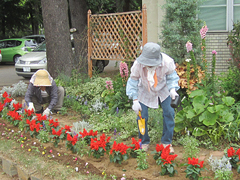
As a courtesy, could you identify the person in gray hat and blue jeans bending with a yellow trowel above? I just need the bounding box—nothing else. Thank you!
[126,42,180,153]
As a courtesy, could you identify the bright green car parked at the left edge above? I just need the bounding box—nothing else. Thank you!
[0,38,37,63]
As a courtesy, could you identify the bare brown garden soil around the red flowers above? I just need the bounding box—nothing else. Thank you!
[0,98,240,180]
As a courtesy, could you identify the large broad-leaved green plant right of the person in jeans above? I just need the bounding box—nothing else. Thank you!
[175,90,235,145]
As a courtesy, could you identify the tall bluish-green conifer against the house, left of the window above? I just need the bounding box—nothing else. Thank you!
[161,0,202,64]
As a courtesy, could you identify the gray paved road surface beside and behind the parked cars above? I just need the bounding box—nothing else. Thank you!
[0,61,119,88]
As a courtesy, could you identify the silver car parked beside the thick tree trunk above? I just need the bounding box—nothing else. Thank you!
[15,41,47,78]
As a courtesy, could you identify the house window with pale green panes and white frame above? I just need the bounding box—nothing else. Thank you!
[199,0,240,32]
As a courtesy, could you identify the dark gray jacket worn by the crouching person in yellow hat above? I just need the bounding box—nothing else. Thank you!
[25,80,58,110]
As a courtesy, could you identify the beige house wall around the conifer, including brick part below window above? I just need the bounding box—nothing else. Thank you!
[142,0,231,74]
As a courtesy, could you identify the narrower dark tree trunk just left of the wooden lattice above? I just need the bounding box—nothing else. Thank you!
[69,0,87,72]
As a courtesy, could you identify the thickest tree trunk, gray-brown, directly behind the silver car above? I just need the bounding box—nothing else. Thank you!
[41,0,73,78]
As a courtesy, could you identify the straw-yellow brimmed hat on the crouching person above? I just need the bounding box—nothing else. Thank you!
[33,70,52,86]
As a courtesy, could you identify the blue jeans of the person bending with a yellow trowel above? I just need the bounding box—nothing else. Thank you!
[137,96,175,144]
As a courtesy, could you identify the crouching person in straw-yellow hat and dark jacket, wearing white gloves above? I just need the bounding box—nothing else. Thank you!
[25,69,64,116]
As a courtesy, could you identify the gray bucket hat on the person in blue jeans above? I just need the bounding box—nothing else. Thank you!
[137,42,162,66]
